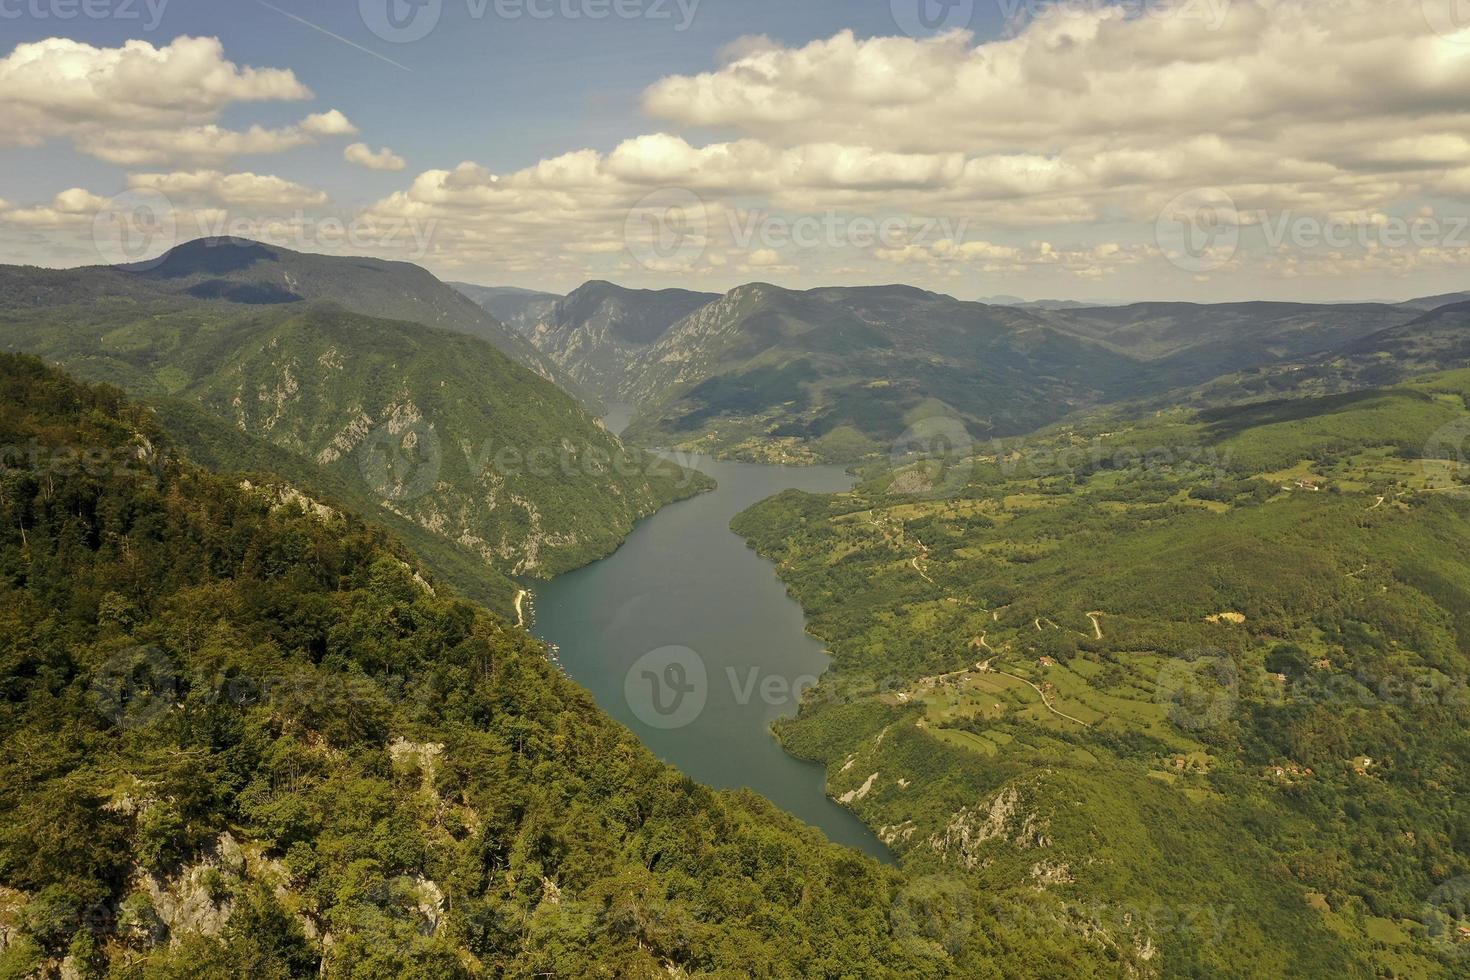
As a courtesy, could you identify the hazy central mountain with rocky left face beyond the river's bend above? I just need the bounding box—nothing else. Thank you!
[623,284,1132,460]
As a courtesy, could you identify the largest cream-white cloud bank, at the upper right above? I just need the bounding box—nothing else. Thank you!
[644,0,1470,216]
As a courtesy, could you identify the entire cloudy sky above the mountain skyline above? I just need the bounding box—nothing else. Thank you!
[0,0,1470,301]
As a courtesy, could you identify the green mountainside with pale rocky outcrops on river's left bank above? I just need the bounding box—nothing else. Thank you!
[0,248,709,608]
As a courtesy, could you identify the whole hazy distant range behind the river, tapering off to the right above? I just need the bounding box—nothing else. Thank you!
[482,282,1439,461]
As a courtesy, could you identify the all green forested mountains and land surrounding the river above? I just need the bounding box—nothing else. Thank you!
[0,241,1470,977]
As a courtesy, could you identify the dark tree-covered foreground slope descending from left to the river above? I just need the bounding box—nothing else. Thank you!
[0,356,893,979]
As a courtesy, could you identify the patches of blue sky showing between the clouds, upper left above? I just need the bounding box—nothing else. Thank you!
[0,0,1001,203]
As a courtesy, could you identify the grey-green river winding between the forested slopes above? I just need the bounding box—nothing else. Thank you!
[532,411,892,861]
